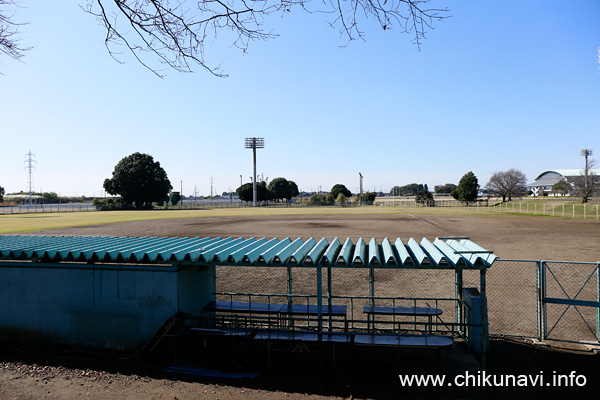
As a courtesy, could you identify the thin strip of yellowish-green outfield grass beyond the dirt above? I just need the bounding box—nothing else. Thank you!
[0,207,489,234]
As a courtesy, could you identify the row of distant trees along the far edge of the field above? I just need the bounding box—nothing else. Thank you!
[81,153,600,209]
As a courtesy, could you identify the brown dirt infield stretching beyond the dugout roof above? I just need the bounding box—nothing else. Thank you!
[30,213,600,262]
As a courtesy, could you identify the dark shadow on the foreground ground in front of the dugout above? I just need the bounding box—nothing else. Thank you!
[0,338,600,399]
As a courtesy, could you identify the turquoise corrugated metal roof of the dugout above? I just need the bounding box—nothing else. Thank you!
[0,235,497,269]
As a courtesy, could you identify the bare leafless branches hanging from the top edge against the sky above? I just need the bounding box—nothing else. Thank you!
[0,0,449,77]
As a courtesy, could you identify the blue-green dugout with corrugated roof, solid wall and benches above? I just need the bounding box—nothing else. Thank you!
[0,235,496,356]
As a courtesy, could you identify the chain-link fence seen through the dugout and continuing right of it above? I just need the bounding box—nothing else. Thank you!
[216,260,600,343]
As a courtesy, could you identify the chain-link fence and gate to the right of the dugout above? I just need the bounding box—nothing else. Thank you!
[487,260,600,345]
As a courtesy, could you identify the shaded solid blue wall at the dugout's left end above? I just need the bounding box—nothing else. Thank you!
[0,262,214,350]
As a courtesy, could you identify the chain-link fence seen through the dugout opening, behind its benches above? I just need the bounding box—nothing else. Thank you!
[216,266,460,332]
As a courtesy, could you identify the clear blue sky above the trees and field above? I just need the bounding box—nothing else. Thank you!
[0,0,600,196]
